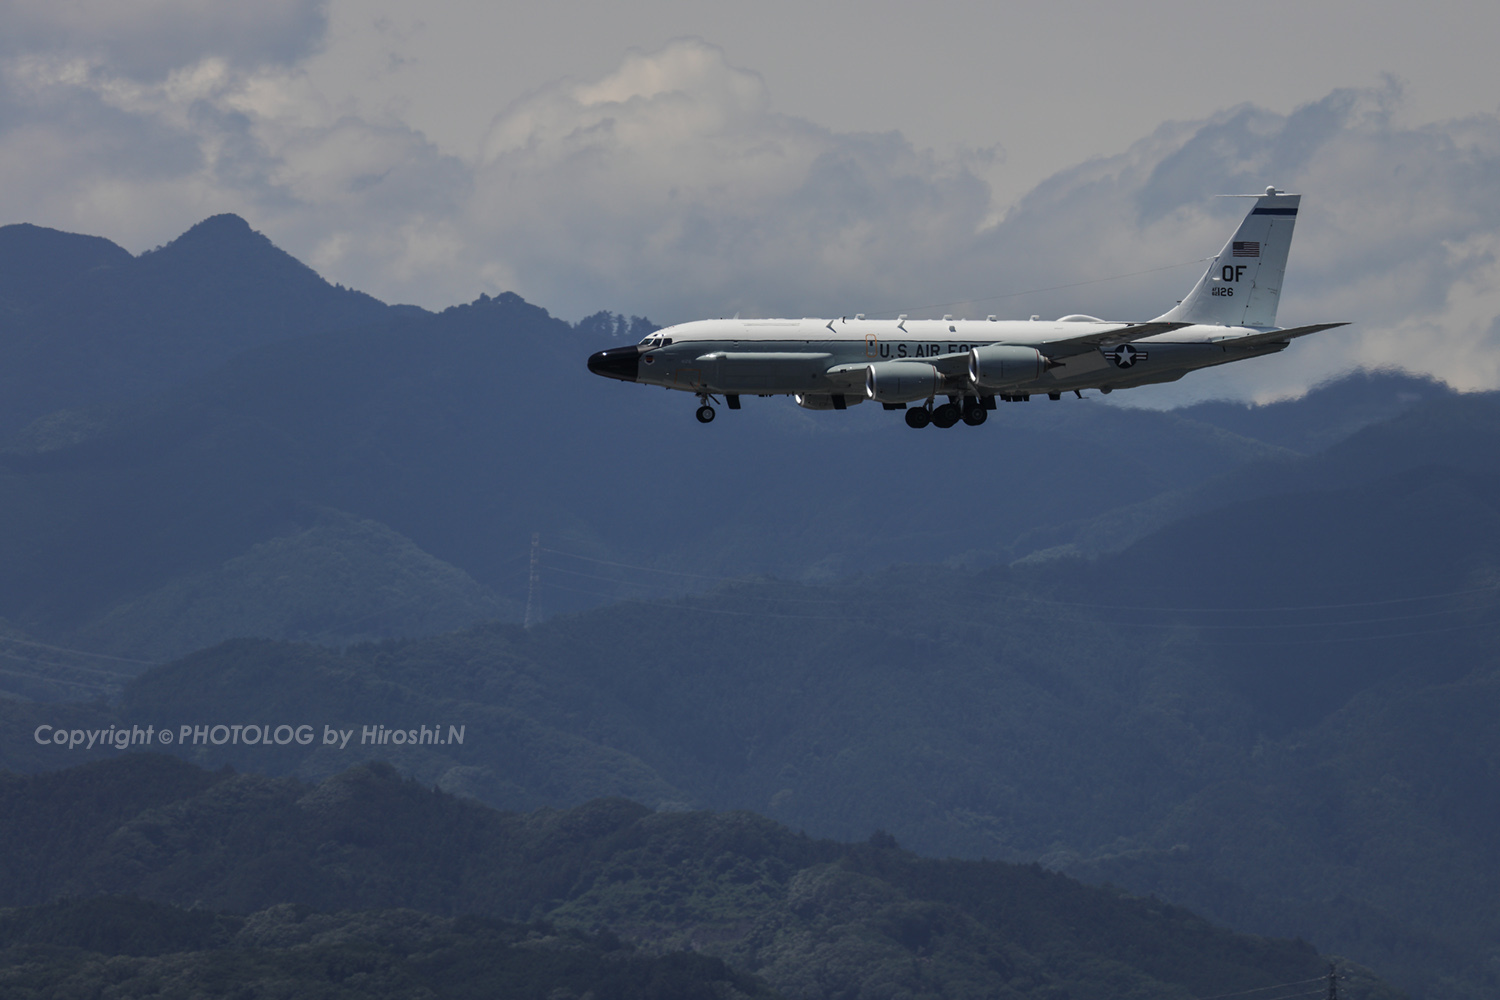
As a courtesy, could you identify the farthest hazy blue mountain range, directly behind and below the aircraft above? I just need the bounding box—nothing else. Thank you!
[0,216,1445,677]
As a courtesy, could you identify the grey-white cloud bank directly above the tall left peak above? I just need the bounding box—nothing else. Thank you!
[0,57,473,284]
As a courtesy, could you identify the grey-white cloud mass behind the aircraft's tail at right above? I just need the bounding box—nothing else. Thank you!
[987,82,1500,397]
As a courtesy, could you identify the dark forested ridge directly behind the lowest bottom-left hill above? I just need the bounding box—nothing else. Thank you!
[0,757,1394,1000]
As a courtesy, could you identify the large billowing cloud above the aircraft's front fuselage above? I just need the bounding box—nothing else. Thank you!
[476,40,989,315]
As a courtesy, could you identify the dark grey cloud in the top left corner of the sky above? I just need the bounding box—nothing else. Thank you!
[0,0,327,79]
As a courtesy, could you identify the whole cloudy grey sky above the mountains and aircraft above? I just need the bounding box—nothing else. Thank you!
[0,0,1500,400]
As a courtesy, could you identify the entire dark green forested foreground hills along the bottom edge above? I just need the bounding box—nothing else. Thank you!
[0,756,1394,1000]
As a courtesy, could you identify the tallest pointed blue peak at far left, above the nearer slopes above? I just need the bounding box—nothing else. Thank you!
[0,214,423,435]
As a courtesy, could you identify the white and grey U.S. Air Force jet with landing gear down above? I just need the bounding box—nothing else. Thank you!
[588,187,1347,427]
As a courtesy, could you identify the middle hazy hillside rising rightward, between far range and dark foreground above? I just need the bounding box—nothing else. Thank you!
[9,397,1500,996]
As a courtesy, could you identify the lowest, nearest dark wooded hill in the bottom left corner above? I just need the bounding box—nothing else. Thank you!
[0,897,779,1000]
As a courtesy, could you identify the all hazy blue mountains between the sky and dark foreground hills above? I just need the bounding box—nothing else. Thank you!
[0,217,1500,997]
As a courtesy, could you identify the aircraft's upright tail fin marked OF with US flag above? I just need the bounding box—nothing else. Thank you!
[1158,187,1302,327]
